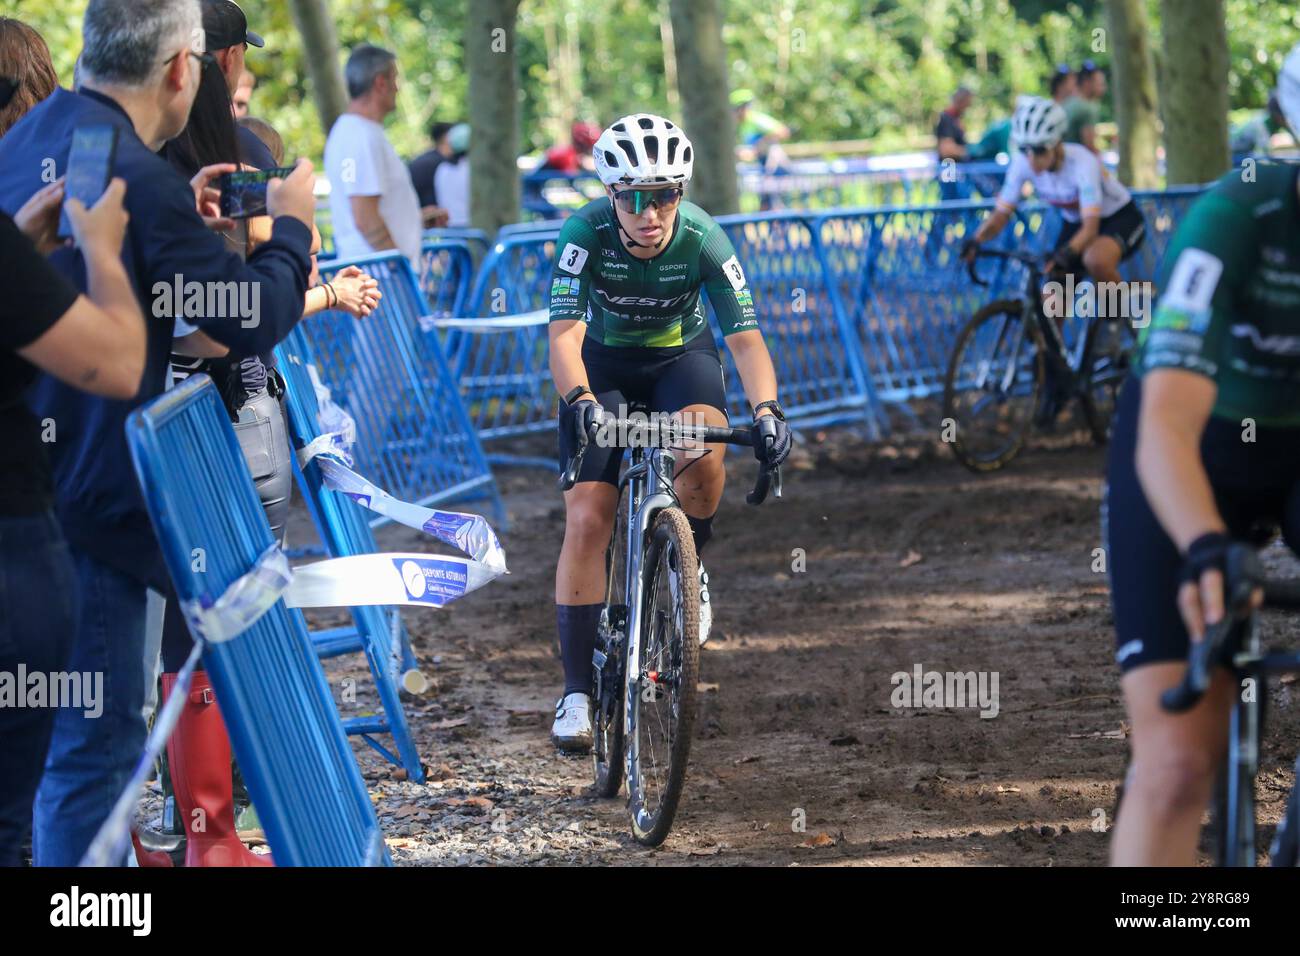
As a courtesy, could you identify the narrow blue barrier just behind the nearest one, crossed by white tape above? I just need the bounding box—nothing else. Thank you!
[276,326,424,783]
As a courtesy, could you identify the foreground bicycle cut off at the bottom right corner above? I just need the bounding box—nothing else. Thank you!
[1161,545,1300,866]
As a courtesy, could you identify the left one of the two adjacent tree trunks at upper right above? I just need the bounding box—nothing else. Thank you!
[1106,0,1160,189]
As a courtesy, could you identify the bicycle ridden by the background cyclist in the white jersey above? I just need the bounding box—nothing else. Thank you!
[944,248,1135,472]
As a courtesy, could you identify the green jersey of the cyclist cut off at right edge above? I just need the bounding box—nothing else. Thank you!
[1135,163,1300,427]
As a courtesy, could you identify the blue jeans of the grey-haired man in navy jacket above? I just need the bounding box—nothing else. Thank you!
[31,550,147,866]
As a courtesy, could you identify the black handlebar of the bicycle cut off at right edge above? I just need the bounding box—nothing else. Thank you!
[1160,544,1300,714]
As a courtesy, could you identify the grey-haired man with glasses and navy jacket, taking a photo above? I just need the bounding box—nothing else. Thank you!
[0,0,315,866]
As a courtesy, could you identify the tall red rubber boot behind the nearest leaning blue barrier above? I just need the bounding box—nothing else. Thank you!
[163,671,273,866]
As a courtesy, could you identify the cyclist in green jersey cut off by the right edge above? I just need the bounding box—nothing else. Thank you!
[1102,47,1300,866]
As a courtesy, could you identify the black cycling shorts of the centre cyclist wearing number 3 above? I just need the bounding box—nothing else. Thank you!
[559,329,727,485]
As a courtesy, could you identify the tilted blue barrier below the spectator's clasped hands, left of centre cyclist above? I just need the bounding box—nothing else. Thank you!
[299,252,506,527]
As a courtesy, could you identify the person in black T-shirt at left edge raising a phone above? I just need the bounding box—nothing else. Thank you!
[0,171,146,866]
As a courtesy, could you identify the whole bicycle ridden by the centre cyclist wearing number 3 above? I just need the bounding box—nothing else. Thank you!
[560,406,781,847]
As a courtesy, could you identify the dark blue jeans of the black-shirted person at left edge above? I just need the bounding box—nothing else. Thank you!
[0,511,77,866]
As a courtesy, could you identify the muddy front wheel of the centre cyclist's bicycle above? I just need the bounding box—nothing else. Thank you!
[627,507,699,847]
